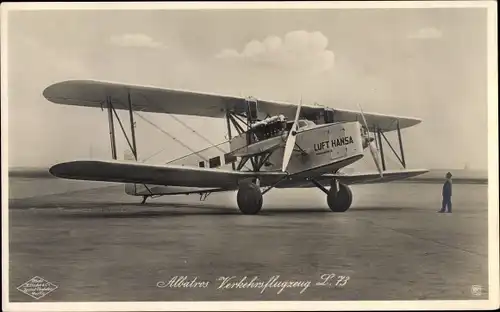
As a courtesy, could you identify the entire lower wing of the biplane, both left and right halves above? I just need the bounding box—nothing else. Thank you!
[49,160,428,190]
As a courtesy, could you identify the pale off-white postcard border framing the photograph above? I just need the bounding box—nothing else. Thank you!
[1,1,500,311]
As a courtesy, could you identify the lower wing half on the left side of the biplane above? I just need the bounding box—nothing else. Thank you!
[49,160,286,189]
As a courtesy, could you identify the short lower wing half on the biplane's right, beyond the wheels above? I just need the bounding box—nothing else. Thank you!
[322,169,429,184]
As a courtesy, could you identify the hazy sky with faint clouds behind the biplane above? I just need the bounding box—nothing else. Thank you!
[3,8,487,170]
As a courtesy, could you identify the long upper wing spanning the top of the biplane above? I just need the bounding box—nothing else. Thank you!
[43,80,421,132]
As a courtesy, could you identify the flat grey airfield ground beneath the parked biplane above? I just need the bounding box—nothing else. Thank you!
[9,179,488,302]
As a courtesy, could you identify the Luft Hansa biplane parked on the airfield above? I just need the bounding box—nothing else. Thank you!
[43,80,428,214]
